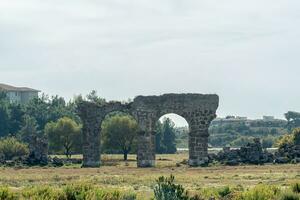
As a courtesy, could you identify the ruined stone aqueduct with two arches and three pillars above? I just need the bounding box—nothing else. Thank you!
[78,94,219,167]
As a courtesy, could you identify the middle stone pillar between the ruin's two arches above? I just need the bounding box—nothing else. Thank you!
[137,131,155,167]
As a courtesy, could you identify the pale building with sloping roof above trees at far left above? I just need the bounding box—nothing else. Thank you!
[0,83,40,104]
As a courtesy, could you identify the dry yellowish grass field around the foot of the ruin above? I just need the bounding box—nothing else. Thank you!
[0,153,300,198]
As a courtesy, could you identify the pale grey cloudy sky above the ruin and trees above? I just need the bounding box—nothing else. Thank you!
[0,0,300,121]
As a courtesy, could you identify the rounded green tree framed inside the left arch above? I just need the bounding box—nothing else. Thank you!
[102,114,138,161]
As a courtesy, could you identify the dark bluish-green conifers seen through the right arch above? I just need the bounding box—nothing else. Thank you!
[156,118,176,154]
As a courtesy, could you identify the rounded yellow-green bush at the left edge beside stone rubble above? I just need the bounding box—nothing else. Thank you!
[0,137,29,160]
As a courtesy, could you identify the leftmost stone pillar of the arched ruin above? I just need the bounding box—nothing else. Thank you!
[82,118,101,167]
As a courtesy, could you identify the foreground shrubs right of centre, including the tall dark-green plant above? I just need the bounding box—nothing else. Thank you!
[154,176,300,200]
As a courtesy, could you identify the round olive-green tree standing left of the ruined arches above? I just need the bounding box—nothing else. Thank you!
[45,117,82,158]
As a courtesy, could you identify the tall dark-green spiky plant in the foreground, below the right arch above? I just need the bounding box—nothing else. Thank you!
[154,175,189,200]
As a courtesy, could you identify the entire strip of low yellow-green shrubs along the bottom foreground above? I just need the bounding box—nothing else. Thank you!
[0,176,300,200]
